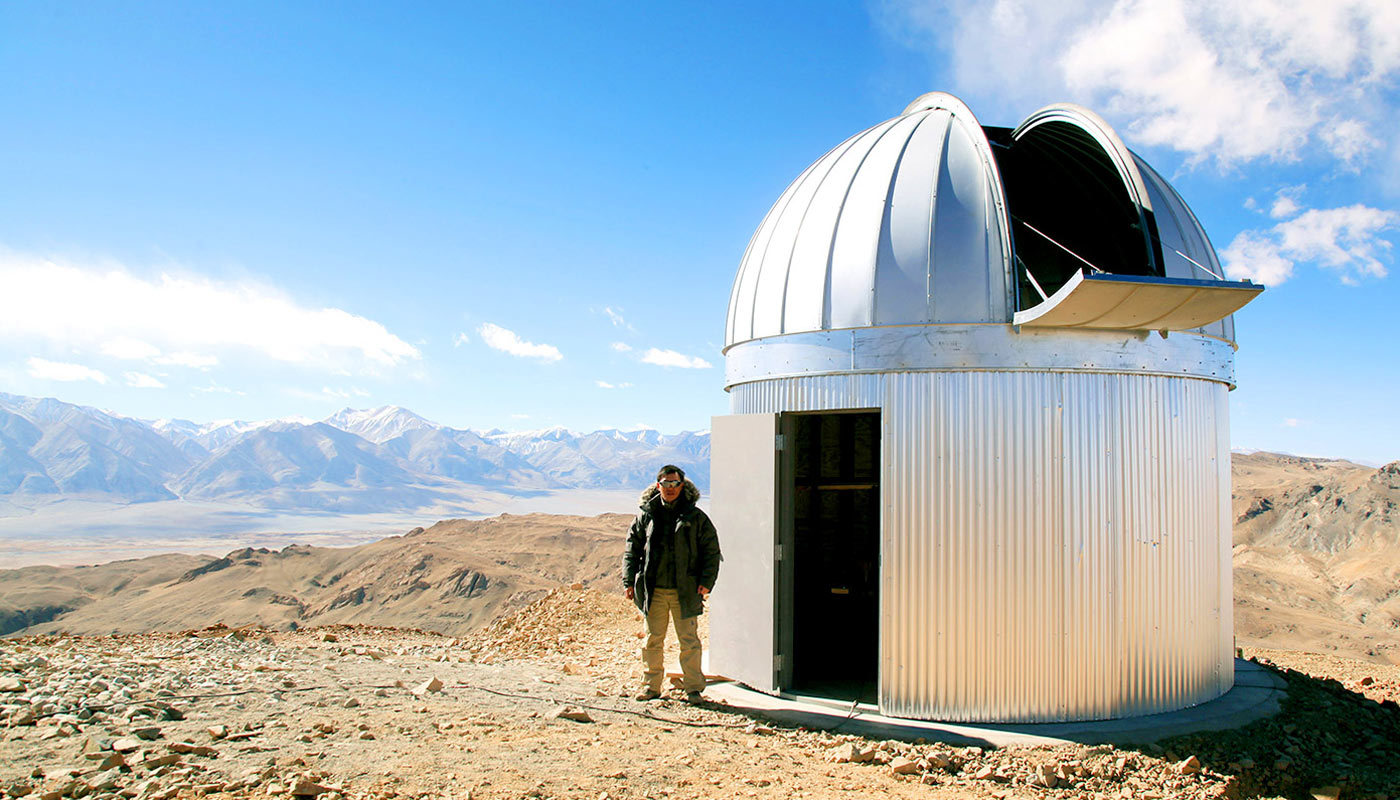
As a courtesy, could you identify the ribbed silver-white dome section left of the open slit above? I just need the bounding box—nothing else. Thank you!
[725,92,1009,346]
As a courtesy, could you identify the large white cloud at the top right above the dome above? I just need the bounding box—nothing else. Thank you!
[883,0,1400,168]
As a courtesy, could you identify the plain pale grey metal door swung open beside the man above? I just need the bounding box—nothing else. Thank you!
[710,413,778,692]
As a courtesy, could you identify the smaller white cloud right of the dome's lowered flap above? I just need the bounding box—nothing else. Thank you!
[1221,205,1400,286]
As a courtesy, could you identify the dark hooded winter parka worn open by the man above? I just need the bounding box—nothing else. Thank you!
[622,478,724,618]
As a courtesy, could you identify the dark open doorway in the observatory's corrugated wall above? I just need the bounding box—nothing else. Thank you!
[781,412,881,702]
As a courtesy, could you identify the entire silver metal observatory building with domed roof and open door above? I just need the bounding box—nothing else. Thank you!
[710,92,1261,722]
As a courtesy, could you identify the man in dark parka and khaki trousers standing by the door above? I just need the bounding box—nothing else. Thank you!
[622,464,724,703]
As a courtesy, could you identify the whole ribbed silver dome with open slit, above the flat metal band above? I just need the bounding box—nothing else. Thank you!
[725,92,1257,350]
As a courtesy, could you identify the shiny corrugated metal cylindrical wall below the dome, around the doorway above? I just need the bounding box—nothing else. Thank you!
[732,371,1233,722]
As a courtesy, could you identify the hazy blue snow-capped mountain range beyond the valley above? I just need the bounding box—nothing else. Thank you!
[0,392,710,513]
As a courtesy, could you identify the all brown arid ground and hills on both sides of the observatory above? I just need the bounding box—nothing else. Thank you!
[0,454,1400,800]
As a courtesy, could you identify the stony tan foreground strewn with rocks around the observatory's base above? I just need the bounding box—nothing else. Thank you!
[0,587,1400,800]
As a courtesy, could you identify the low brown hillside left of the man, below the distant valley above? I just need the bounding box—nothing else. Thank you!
[0,514,630,635]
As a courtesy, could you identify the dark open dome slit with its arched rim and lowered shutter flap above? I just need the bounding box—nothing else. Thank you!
[1001,104,1263,331]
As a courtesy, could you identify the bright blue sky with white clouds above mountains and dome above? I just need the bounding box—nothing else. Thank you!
[0,0,1400,464]
